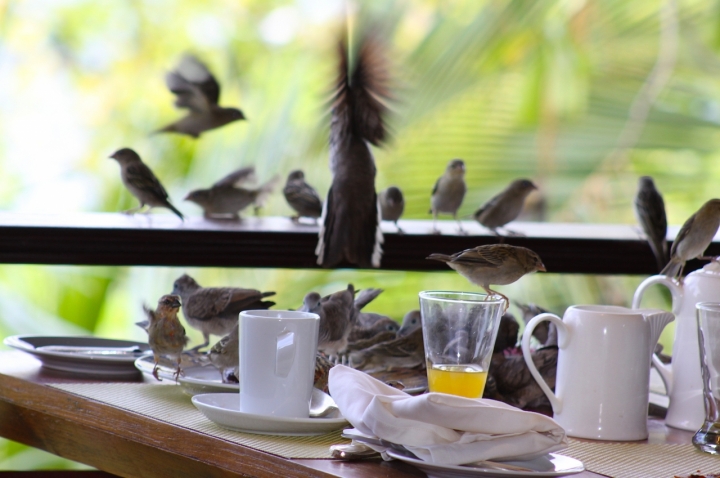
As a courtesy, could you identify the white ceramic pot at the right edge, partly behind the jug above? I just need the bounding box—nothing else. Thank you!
[633,261,720,431]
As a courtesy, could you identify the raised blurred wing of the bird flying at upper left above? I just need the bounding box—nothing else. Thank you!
[165,55,220,113]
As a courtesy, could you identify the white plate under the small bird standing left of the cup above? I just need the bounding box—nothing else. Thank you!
[135,355,240,397]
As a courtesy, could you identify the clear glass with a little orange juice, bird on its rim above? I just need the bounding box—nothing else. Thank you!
[420,291,505,398]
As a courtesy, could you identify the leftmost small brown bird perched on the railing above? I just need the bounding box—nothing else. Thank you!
[110,148,183,219]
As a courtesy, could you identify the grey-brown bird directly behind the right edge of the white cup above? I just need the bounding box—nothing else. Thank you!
[298,284,357,357]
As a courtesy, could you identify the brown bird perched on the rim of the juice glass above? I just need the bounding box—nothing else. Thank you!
[427,244,545,310]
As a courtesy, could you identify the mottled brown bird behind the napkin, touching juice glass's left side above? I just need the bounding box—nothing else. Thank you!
[349,329,425,373]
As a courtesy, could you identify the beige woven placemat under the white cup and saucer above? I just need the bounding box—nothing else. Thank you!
[50,383,350,458]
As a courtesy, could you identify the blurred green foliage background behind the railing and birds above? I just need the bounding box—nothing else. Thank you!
[0,0,720,470]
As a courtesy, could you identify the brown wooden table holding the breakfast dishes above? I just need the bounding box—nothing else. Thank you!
[0,351,692,478]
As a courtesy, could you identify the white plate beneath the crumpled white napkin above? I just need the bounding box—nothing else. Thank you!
[387,449,585,478]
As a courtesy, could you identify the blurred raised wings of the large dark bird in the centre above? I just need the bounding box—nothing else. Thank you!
[331,33,390,145]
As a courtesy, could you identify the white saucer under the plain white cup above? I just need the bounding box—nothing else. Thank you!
[192,393,347,436]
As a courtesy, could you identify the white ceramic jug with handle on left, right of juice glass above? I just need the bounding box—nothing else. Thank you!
[522,305,674,440]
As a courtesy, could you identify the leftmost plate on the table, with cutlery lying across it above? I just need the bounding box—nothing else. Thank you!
[3,335,152,378]
